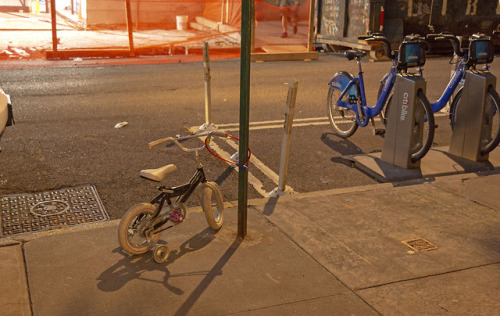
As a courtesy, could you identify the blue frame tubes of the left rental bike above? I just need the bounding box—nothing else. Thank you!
[330,60,397,127]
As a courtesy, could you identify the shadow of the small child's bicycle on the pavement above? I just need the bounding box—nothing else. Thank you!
[97,228,215,295]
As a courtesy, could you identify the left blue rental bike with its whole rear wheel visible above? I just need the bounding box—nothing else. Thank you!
[327,33,434,161]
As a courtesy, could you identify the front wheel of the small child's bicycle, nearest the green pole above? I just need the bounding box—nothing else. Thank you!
[201,182,224,230]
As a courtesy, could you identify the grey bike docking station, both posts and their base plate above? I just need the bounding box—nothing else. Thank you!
[343,38,500,182]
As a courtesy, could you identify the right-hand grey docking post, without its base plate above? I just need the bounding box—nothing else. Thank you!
[448,70,496,161]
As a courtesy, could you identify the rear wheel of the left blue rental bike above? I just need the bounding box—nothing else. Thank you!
[326,87,358,138]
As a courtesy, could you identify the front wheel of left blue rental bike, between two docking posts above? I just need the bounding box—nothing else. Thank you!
[410,90,436,162]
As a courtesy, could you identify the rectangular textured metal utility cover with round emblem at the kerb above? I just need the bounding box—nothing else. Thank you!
[0,185,109,237]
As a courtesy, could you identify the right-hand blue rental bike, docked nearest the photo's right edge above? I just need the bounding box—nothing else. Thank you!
[380,32,500,155]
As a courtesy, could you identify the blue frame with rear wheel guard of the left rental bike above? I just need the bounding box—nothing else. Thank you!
[330,59,397,127]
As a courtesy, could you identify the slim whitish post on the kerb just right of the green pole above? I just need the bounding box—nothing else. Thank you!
[269,80,299,197]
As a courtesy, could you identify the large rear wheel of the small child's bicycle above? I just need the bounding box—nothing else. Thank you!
[118,203,160,255]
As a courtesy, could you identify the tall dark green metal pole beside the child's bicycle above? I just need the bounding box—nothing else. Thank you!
[238,0,255,238]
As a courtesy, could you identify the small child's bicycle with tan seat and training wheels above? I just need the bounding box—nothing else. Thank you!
[118,132,234,263]
